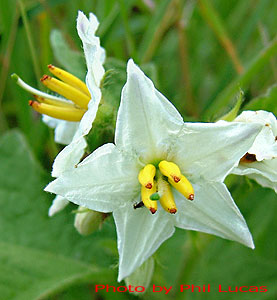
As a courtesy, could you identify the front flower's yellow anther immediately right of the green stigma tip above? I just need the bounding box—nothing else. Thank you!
[157,177,177,214]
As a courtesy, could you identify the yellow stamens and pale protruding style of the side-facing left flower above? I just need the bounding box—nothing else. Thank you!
[13,65,91,122]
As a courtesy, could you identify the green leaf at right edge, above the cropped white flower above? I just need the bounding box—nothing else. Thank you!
[244,84,277,116]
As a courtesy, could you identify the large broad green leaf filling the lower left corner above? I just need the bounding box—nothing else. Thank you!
[0,131,117,300]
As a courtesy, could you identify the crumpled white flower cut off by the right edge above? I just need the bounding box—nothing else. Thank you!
[232,110,277,193]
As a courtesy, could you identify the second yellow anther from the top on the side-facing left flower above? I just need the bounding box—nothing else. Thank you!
[40,75,90,109]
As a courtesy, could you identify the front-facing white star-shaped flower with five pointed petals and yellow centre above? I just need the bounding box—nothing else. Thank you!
[45,60,261,281]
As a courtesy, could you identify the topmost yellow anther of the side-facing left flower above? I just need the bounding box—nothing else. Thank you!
[48,65,90,97]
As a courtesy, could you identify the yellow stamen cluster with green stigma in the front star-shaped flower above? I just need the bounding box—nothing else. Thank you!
[138,160,194,214]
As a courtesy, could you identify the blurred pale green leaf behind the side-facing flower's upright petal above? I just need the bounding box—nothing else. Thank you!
[50,29,86,80]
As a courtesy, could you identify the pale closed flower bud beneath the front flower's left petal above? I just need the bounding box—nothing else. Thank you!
[74,206,107,235]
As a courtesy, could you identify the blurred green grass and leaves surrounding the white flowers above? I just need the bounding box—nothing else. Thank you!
[0,0,277,300]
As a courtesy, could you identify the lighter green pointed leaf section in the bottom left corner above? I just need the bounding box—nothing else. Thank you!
[0,242,97,300]
